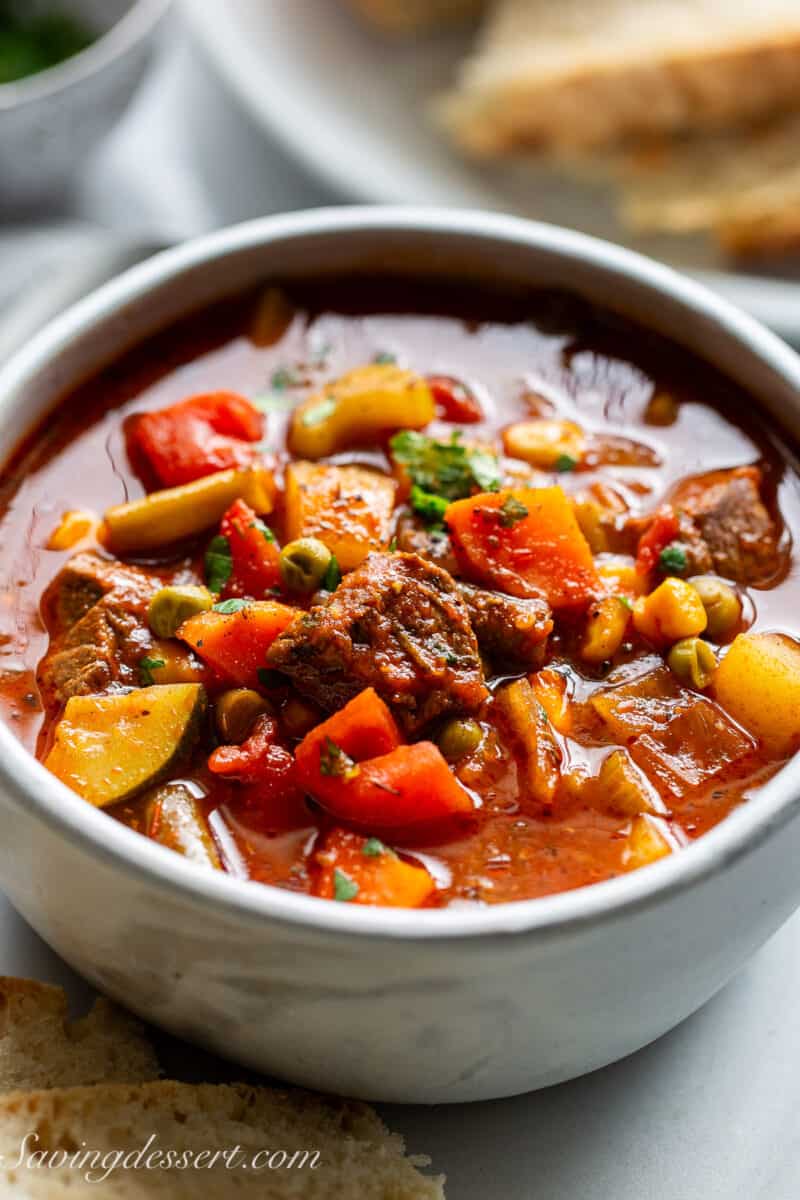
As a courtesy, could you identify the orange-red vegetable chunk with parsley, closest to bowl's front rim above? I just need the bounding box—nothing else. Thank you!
[313,829,435,908]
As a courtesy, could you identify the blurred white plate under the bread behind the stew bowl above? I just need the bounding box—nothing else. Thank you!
[184,0,800,340]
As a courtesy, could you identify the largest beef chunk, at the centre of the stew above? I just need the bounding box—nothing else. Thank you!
[267,554,487,733]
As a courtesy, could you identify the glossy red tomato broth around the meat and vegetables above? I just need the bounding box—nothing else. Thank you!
[0,281,800,905]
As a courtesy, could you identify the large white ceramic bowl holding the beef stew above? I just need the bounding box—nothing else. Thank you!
[0,209,800,1102]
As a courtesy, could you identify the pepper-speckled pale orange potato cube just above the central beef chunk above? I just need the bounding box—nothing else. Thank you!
[285,462,397,571]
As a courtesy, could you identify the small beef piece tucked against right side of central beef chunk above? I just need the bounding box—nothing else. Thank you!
[458,583,553,671]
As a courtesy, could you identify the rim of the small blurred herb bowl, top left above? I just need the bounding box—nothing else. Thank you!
[0,0,173,113]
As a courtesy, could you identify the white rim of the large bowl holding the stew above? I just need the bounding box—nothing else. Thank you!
[0,208,800,942]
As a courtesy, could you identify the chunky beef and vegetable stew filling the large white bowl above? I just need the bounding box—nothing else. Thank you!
[0,280,800,907]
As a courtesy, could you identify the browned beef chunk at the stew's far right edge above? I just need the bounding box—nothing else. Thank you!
[673,467,783,584]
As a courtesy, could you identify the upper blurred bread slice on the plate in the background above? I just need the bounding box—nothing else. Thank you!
[440,0,800,156]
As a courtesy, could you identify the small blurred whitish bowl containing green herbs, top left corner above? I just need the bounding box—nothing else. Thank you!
[0,0,170,206]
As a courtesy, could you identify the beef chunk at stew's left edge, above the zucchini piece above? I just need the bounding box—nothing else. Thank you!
[38,553,161,706]
